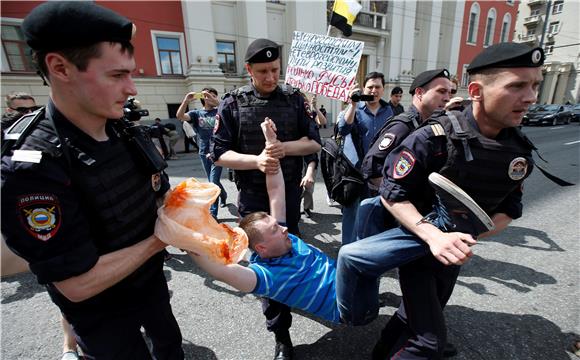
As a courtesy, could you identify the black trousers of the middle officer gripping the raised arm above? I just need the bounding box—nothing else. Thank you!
[238,184,302,335]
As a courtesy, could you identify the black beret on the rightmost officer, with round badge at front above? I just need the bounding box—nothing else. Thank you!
[467,43,544,74]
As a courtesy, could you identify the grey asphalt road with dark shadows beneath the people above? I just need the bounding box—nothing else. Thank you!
[0,123,580,360]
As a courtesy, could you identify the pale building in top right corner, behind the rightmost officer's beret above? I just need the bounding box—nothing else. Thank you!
[515,0,580,104]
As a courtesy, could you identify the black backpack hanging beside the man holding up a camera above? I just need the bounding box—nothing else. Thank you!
[320,122,365,206]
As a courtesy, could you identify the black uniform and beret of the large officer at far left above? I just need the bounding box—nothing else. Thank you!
[1,2,184,359]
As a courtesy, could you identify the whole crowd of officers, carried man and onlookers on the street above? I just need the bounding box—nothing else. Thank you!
[1,2,544,360]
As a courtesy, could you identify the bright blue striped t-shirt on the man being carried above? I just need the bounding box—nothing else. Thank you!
[249,234,340,323]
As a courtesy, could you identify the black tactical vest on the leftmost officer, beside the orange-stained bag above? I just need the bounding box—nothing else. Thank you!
[24,119,157,254]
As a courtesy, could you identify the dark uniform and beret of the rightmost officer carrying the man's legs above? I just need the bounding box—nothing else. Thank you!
[372,43,543,359]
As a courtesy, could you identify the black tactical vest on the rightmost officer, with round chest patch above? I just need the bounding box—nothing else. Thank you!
[428,111,533,215]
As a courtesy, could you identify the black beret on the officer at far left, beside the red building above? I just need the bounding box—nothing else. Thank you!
[22,1,133,51]
